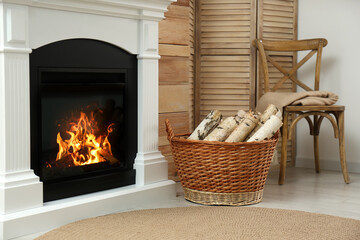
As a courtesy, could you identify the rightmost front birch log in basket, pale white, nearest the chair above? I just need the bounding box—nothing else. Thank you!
[247,115,282,142]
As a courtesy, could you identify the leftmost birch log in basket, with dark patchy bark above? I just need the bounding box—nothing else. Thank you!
[188,110,222,140]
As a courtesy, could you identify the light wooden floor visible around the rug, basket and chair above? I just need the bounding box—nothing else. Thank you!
[13,168,360,240]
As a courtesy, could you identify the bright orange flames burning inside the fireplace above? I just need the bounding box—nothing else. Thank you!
[56,112,117,166]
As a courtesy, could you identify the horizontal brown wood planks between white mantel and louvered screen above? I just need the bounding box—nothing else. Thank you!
[159,0,194,180]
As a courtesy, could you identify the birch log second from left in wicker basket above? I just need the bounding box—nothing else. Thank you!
[204,117,239,141]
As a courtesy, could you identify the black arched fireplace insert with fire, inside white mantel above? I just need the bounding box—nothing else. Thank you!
[30,39,137,202]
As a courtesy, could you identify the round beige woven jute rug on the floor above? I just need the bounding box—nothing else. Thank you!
[37,207,360,240]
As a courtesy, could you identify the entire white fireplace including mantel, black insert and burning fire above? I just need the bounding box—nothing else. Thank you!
[0,0,176,239]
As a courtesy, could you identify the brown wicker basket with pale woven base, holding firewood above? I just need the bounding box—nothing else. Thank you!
[165,119,279,206]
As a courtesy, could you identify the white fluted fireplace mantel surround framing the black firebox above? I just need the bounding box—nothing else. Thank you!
[0,0,175,239]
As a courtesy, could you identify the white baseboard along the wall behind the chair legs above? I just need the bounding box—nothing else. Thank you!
[295,157,360,173]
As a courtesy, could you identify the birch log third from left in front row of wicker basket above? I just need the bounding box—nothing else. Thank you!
[225,112,259,142]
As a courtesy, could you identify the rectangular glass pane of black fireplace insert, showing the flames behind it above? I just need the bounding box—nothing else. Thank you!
[41,87,126,181]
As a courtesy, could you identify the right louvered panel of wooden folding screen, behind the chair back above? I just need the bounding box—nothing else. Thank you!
[257,0,298,165]
